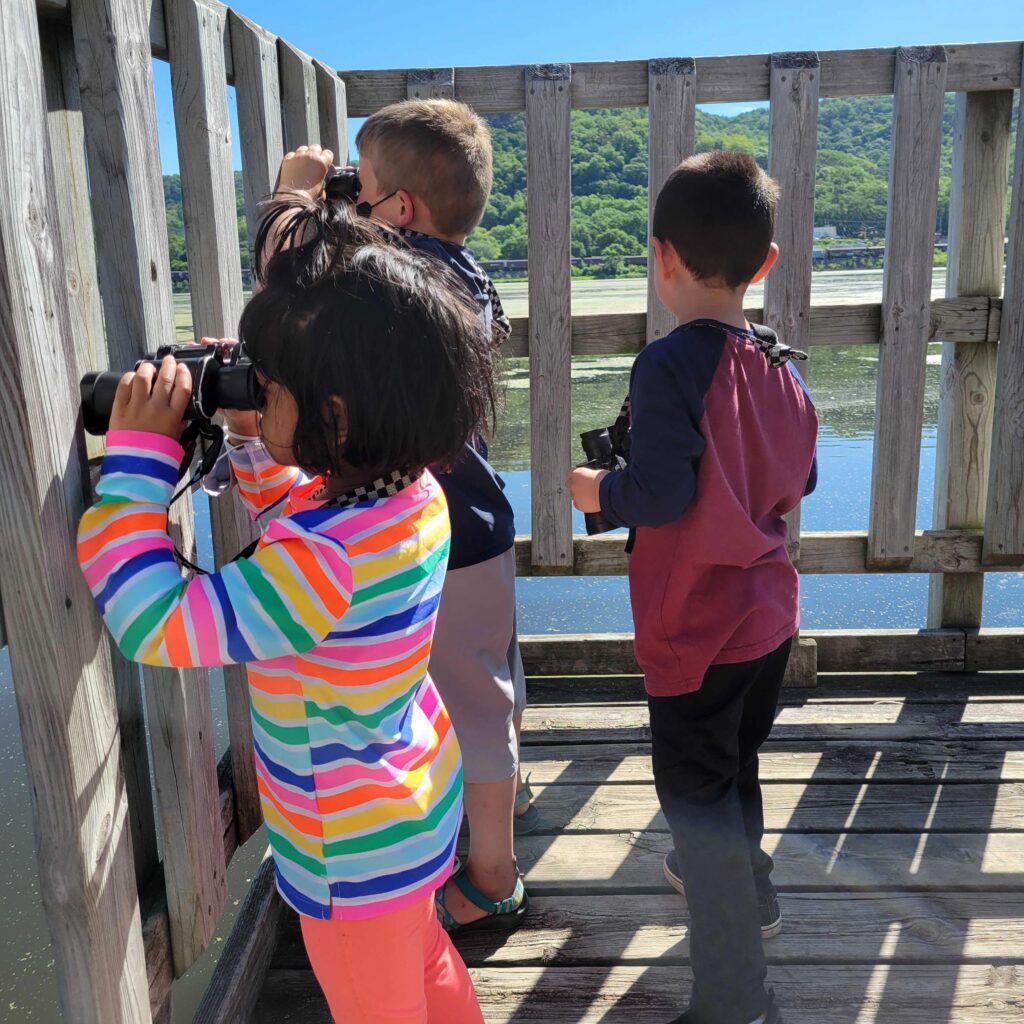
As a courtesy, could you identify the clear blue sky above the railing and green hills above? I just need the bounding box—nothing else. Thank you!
[155,0,1024,172]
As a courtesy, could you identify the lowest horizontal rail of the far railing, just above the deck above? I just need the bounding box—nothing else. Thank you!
[519,629,1024,676]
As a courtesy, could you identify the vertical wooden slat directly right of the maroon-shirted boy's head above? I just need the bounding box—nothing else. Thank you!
[764,53,821,686]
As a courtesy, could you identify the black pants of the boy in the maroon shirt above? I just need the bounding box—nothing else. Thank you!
[647,639,793,1024]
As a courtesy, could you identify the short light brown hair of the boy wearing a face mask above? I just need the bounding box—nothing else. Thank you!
[355,99,493,234]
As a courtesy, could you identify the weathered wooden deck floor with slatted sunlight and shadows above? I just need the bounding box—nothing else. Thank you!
[247,677,1024,1024]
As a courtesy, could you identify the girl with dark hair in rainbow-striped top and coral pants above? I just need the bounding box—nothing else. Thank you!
[79,197,496,1024]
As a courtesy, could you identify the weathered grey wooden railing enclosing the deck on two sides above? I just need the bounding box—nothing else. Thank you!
[6,0,1024,1024]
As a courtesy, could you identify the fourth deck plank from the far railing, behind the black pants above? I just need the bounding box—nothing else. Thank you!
[497,779,1024,836]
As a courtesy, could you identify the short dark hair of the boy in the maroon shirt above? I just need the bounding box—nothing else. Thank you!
[651,151,779,288]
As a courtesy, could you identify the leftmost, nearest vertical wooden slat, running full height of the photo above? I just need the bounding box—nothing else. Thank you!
[0,0,151,1024]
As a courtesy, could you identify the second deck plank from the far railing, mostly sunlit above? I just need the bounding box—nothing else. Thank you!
[522,699,1024,745]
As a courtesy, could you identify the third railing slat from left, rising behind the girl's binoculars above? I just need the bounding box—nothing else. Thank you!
[166,0,262,847]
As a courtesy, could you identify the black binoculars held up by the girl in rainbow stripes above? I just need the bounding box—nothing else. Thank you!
[79,344,262,434]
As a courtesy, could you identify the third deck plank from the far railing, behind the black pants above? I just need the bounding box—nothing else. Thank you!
[522,733,1024,786]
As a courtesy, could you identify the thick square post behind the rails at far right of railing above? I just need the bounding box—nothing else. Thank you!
[928,91,1014,629]
